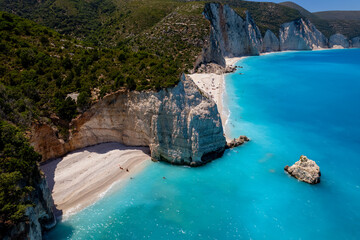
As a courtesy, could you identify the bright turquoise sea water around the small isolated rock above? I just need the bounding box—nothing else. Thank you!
[47,49,360,239]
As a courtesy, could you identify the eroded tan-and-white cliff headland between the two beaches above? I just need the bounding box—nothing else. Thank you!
[31,75,226,166]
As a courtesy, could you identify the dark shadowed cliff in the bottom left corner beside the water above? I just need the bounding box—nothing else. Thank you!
[3,178,56,240]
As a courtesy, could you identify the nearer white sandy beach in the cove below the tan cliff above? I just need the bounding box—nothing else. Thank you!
[40,143,150,216]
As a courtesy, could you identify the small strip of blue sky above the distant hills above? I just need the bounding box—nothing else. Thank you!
[250,0,360,12]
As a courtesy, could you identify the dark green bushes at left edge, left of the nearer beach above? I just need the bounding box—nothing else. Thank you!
[0,121,41,228]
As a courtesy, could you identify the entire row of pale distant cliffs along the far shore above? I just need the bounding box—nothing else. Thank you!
[194,3,360,71]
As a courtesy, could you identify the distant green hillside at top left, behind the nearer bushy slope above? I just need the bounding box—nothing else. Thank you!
[0,0,179,46]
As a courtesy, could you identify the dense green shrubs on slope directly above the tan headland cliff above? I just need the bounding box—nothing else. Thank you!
[0,12,191,129]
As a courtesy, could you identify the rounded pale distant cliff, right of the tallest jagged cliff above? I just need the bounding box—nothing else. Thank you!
[280,18,328,51]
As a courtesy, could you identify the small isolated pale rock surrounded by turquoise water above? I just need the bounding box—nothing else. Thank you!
[284,155,321,184]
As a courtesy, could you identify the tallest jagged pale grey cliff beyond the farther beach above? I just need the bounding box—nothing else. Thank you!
[195,3,262,68]
